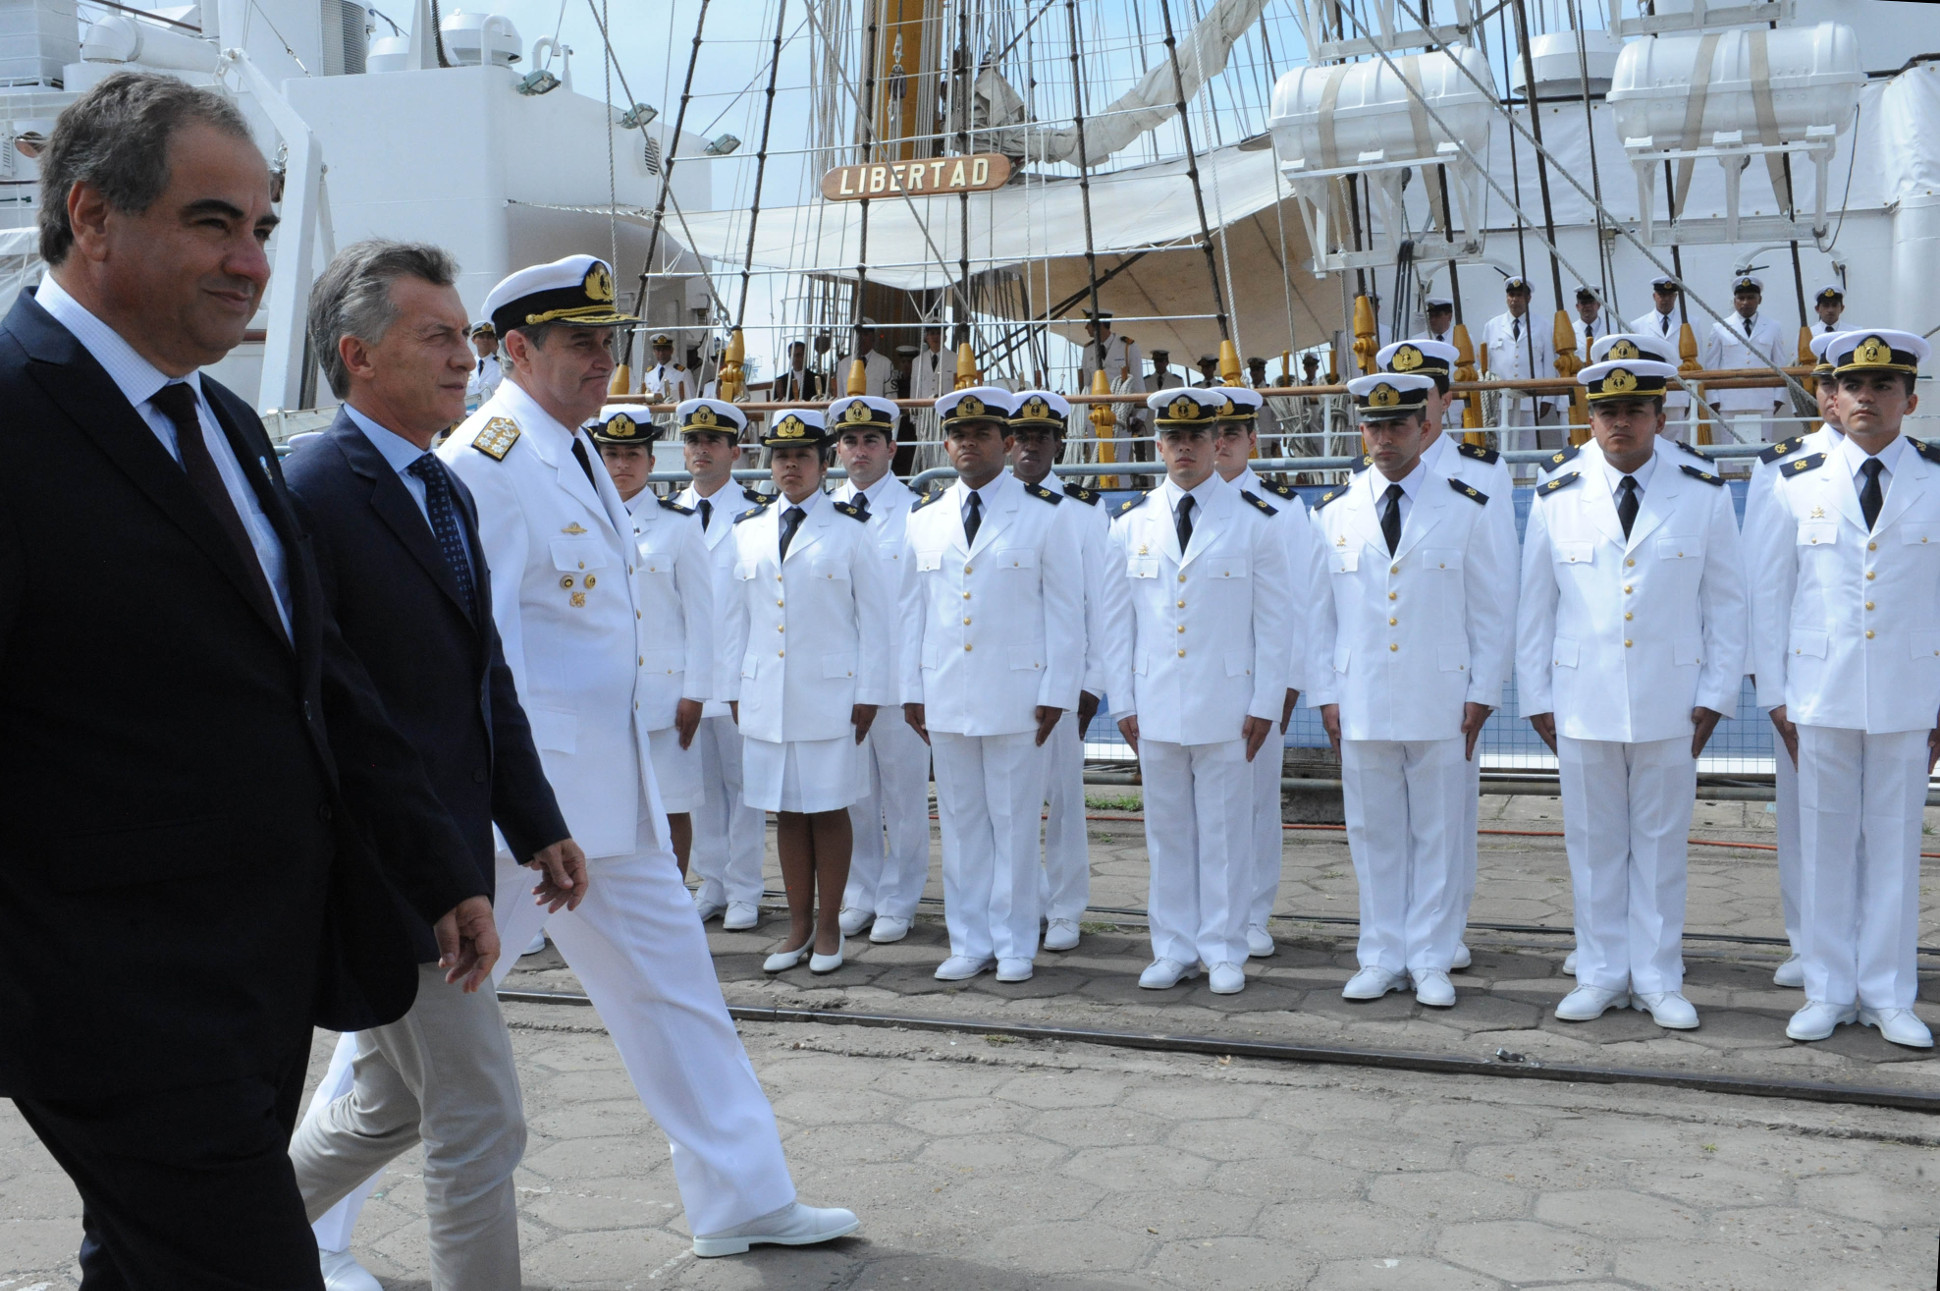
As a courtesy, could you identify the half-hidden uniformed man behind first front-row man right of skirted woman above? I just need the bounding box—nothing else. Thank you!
[1009,390,1112,951]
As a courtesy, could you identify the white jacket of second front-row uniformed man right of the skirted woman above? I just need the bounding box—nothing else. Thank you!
[1106,476,1294,744]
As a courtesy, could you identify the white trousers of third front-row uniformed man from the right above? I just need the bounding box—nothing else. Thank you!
[1341,736,1472,973]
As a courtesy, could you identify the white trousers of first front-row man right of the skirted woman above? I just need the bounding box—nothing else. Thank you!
[929,730,1044,959]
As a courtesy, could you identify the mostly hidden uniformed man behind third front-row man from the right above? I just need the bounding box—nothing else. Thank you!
[1374,338,1521,969]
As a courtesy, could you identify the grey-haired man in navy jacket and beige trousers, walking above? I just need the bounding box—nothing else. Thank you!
[287,241,586,1291]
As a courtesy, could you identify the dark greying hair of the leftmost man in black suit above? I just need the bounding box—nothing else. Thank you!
[39,72,254,264]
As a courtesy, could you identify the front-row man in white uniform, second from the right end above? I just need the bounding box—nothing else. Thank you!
[1515,359,1750,1031]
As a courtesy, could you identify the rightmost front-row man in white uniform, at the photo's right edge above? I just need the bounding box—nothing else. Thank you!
[1752,330,1940,1048]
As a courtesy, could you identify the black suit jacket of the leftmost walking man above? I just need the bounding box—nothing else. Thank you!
[0,293,491,1099]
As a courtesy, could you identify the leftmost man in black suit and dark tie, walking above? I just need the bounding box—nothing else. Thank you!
[0,74,499,1291]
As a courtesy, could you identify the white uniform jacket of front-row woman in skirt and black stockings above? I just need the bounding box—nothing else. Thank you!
[722,495,894,744]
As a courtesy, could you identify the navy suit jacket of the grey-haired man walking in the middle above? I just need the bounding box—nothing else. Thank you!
[283,412,568,963]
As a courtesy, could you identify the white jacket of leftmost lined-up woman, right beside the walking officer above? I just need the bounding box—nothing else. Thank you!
[632,493,718,730]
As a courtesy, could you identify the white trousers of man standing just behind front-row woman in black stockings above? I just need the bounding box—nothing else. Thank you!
[842,707,929,918]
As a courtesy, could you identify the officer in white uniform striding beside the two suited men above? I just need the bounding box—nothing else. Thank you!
[438,256,857,1256]
